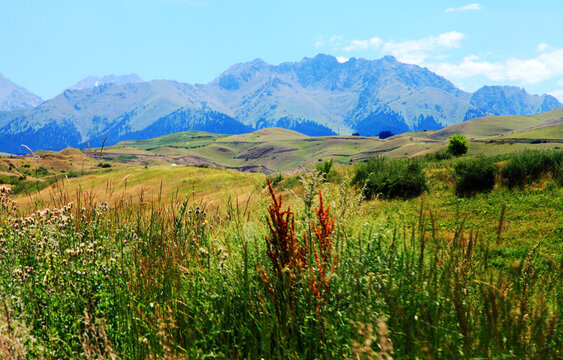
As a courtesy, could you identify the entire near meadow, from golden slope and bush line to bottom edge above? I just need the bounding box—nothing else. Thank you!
[0,148,563,359]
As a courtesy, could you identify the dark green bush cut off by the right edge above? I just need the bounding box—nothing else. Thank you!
[501,150,563,188]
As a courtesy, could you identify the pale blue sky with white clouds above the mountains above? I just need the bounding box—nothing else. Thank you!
[0,0,563,101]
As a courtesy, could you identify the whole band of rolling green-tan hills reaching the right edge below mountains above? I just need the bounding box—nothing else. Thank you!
[94,108,563,173]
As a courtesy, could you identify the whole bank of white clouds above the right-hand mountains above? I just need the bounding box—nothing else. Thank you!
[318,31,563,94]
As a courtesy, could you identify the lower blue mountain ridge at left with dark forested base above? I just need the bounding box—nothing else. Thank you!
[0,80,232,153]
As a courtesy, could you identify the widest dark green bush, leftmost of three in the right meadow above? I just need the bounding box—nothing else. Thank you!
[352,157,427,199]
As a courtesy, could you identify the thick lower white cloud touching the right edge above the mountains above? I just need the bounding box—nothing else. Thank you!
[429,49,563,84]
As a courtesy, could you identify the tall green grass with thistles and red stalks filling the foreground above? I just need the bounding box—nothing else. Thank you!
[0,167,563,359]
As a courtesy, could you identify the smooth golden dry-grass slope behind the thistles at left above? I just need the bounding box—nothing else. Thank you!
[15,165,265,210]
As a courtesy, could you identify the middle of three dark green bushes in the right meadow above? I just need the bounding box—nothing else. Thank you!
[454,157,497,196]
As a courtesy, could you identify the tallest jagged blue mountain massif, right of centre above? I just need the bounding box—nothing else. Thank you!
[205,55,472,135]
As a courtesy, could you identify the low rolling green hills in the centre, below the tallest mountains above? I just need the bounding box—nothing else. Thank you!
[104,128,388,172]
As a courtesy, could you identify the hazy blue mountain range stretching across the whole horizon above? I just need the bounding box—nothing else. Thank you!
[0,54,562,153]
